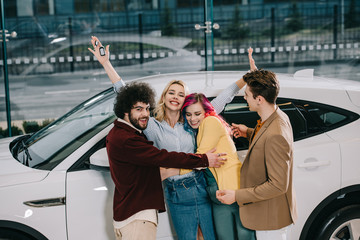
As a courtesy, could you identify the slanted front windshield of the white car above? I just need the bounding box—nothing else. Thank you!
[17,89,116,170]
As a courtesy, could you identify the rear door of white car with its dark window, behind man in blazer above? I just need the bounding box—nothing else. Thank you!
[222,97,341,239]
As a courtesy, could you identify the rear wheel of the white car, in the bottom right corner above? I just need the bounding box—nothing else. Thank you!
[316,205,360,240]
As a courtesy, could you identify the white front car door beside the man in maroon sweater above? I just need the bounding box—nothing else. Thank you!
[66,136,115,240]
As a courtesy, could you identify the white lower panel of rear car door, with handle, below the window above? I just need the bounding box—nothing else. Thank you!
[291,133,341,239]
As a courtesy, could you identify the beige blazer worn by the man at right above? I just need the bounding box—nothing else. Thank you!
[236,108,297,230]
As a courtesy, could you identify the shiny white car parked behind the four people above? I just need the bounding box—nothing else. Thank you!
[0,70,360,240]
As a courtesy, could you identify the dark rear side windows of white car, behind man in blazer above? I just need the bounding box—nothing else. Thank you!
[221,96,359,150]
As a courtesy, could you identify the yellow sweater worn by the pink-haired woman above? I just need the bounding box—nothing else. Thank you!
[180,116,241,190]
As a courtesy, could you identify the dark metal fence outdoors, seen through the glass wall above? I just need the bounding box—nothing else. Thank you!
[0,5,360,75]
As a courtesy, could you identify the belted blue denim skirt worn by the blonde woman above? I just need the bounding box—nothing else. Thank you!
[163,171,215,240]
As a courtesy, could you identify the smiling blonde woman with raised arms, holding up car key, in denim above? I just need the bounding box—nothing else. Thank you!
[89,37,243,240]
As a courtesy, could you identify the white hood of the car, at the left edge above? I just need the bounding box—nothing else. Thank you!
[0,138,49,187]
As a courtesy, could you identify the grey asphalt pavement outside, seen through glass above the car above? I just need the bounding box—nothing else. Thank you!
[0,57,360,128]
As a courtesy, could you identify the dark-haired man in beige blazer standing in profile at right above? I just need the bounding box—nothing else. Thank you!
[217,66,297,240]
